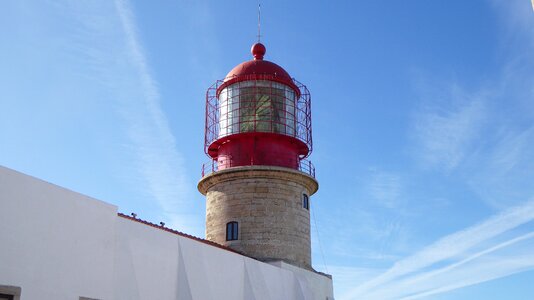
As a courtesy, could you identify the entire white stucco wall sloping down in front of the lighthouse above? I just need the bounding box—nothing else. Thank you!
[0,166,333,300]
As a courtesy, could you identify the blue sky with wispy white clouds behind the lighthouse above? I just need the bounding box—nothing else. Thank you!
[0,0,534,300]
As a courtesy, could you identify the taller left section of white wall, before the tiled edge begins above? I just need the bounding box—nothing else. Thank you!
[0,166,117,300]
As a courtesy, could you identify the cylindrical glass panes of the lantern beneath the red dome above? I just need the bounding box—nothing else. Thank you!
[219,80,296,137]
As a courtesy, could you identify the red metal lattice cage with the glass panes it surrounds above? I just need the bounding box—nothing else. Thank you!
[204,76,313,158]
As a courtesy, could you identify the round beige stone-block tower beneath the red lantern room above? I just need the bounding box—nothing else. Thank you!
[198,166,318,270]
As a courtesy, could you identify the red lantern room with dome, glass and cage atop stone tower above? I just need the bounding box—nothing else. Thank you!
[202,43,315,176]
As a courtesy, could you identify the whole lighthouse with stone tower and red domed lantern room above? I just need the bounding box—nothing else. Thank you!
[198,43,318,270]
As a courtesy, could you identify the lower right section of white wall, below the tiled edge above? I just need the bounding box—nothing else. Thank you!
[115,218,333,300]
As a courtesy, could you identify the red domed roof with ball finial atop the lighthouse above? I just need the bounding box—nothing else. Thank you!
[217,43,300,96]
